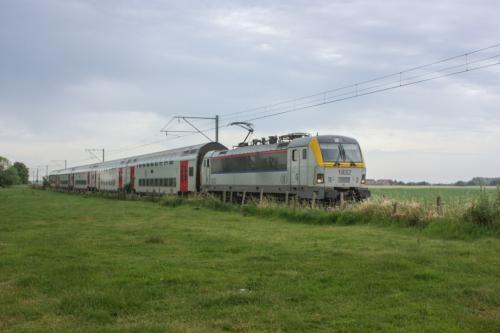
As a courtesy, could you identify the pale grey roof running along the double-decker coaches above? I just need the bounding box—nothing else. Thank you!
[51,142,225,175]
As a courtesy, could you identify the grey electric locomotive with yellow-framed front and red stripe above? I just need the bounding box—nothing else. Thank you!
[201,133,370,201]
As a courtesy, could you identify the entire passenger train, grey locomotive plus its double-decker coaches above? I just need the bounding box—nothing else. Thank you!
[49,133,370,202]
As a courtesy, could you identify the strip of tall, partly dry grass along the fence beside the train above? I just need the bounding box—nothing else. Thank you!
[47,188,500,236]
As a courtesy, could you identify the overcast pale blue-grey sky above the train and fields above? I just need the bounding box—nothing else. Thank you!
[0,0,500,182]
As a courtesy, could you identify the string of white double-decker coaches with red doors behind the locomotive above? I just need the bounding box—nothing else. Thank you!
[49,142,227,194]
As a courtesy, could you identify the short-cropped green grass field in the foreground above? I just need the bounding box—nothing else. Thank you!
[0,188,500,332]
